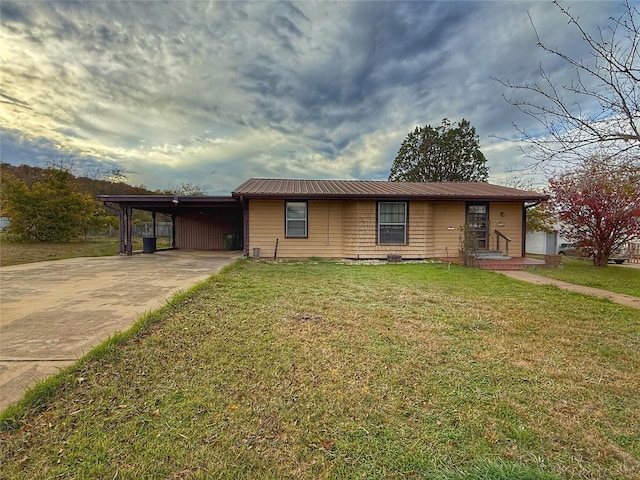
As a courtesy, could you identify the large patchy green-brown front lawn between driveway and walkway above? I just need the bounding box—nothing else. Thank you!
[0,261,640,480]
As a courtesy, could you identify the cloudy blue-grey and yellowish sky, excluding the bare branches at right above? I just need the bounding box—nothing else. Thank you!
[0,0,622,195]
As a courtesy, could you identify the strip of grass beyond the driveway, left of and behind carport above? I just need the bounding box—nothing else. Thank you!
[0,235,168,267]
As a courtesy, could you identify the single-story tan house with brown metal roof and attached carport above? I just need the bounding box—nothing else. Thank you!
[100,178,547,259]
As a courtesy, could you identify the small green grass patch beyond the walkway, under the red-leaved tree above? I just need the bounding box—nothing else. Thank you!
[534,258,640,297]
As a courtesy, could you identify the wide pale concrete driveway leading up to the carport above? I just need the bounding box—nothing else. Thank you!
[0,250,242,410]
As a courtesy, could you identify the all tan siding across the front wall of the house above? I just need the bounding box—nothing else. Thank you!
[248,200,522,259]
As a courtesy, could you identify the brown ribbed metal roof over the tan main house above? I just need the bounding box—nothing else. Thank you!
[232,178,548,202]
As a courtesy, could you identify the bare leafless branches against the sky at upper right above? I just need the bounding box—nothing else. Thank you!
[496,0,640,168]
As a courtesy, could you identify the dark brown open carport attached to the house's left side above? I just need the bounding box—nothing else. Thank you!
[98,195,244,255]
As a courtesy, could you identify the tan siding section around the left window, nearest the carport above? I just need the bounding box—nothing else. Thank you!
[249,200,344,258]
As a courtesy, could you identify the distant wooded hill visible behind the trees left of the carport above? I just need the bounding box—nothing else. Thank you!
[0,163,158,198]
